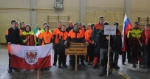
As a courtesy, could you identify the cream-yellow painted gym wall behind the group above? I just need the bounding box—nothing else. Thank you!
[0,0,150,43]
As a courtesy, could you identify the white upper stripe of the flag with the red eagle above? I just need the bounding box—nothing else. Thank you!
[11,43,53,58]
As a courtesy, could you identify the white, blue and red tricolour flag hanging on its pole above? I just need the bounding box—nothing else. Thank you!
[122,14,132,52]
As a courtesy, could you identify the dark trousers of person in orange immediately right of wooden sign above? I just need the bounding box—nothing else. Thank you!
[87,44,94,62]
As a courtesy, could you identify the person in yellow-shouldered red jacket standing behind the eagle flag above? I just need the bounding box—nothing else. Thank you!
[22,25,36,46]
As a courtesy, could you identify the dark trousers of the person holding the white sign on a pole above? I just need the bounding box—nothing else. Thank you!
[100,48,113,73]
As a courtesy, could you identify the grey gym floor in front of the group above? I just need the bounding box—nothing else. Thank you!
[0,46,150,79]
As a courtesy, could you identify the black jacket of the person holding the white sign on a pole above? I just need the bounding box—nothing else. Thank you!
[98,29,114,49]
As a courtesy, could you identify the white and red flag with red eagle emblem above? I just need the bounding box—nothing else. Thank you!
[11,44,53,70]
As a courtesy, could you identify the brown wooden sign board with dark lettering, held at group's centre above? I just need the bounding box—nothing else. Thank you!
[65,43,87,55]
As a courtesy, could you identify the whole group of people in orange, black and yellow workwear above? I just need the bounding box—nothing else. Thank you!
[6,16,150,76]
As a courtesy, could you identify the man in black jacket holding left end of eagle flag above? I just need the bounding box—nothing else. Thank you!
[5,20,22,73]
